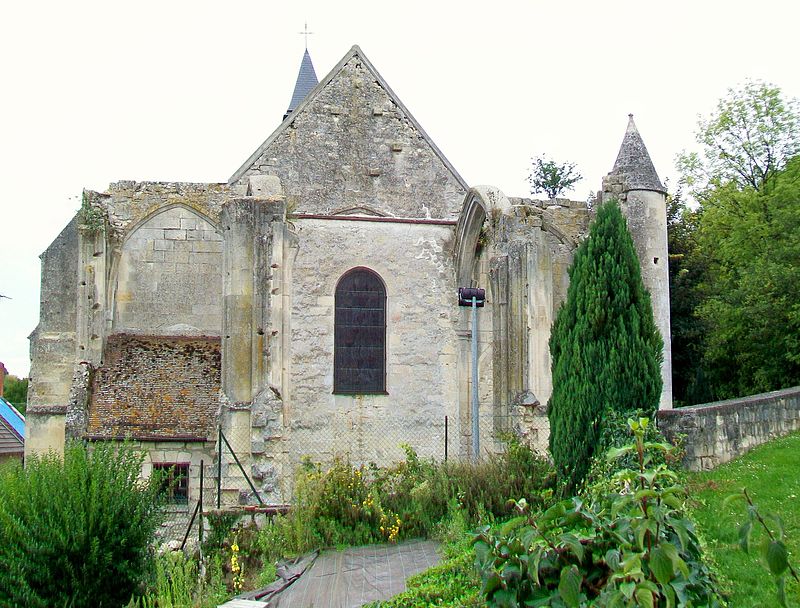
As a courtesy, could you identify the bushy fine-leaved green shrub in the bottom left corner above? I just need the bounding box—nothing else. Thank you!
[0,442,160,608]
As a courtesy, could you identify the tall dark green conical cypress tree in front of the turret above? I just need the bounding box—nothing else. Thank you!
[548,201,663,488]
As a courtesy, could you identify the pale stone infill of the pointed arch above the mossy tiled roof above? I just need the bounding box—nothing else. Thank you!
[113,206,222,335]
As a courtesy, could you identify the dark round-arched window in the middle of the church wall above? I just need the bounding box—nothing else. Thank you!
[333,268,386,395]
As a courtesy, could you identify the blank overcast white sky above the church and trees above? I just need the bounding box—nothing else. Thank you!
[0,0,800,375]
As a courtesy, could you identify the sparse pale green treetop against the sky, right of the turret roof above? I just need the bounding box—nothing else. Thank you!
[678,81,800,192]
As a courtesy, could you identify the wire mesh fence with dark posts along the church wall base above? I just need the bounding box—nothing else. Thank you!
[159,414,548,544]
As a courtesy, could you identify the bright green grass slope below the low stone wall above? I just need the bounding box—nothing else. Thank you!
[687,434,800,608]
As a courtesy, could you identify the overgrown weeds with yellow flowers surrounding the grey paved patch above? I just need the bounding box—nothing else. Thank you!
[126,437,554,608]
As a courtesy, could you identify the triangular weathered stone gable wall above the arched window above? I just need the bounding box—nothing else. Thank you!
[237,56,466,219]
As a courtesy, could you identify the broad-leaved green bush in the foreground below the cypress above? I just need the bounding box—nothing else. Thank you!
[475,419,721,608]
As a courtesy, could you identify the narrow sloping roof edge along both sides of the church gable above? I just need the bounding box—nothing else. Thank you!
[228,45,469,191]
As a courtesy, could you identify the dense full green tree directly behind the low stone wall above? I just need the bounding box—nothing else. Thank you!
[698,157,800,399]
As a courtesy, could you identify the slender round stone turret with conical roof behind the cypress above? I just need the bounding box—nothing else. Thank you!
[602,114,672,409]
